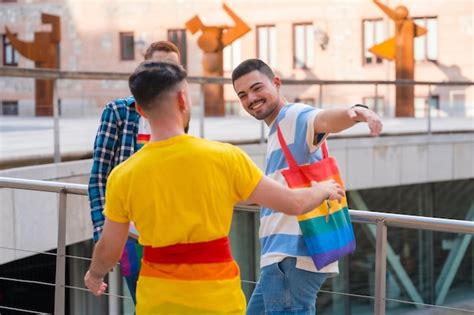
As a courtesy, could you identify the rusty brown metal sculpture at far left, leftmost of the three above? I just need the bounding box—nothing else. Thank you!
[5,13,61,116]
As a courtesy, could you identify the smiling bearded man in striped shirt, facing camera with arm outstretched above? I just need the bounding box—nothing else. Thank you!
[232,59,382,315]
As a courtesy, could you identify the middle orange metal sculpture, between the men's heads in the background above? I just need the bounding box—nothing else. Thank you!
[186,4,250,116]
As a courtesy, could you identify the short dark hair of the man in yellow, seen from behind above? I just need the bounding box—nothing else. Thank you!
[128,61,186,110]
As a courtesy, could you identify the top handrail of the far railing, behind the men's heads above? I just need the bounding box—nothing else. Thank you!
[0,66,474,86]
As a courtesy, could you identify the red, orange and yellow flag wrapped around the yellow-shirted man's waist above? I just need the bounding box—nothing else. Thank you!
[133,237,246,315]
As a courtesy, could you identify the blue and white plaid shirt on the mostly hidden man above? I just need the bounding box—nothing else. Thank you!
[89,96,140,241]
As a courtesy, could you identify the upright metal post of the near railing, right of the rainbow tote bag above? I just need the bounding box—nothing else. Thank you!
[374,220,387,315]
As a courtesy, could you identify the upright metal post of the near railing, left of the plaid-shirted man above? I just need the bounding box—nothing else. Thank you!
[54,189,67,315]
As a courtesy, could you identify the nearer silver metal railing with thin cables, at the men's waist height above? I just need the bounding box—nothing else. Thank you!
[0,177,474,315]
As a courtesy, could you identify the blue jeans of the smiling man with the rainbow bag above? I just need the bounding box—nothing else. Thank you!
[247,257,327,315]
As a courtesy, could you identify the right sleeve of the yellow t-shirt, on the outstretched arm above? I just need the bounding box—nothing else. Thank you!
[231,146,263,201]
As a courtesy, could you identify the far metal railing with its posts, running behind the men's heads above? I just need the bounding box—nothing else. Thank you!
[0,67,474,163]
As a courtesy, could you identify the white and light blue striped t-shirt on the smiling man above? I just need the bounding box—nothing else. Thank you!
[259,103,339,273]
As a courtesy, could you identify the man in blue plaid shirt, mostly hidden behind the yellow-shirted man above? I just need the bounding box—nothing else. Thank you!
[89,41,180,301]
